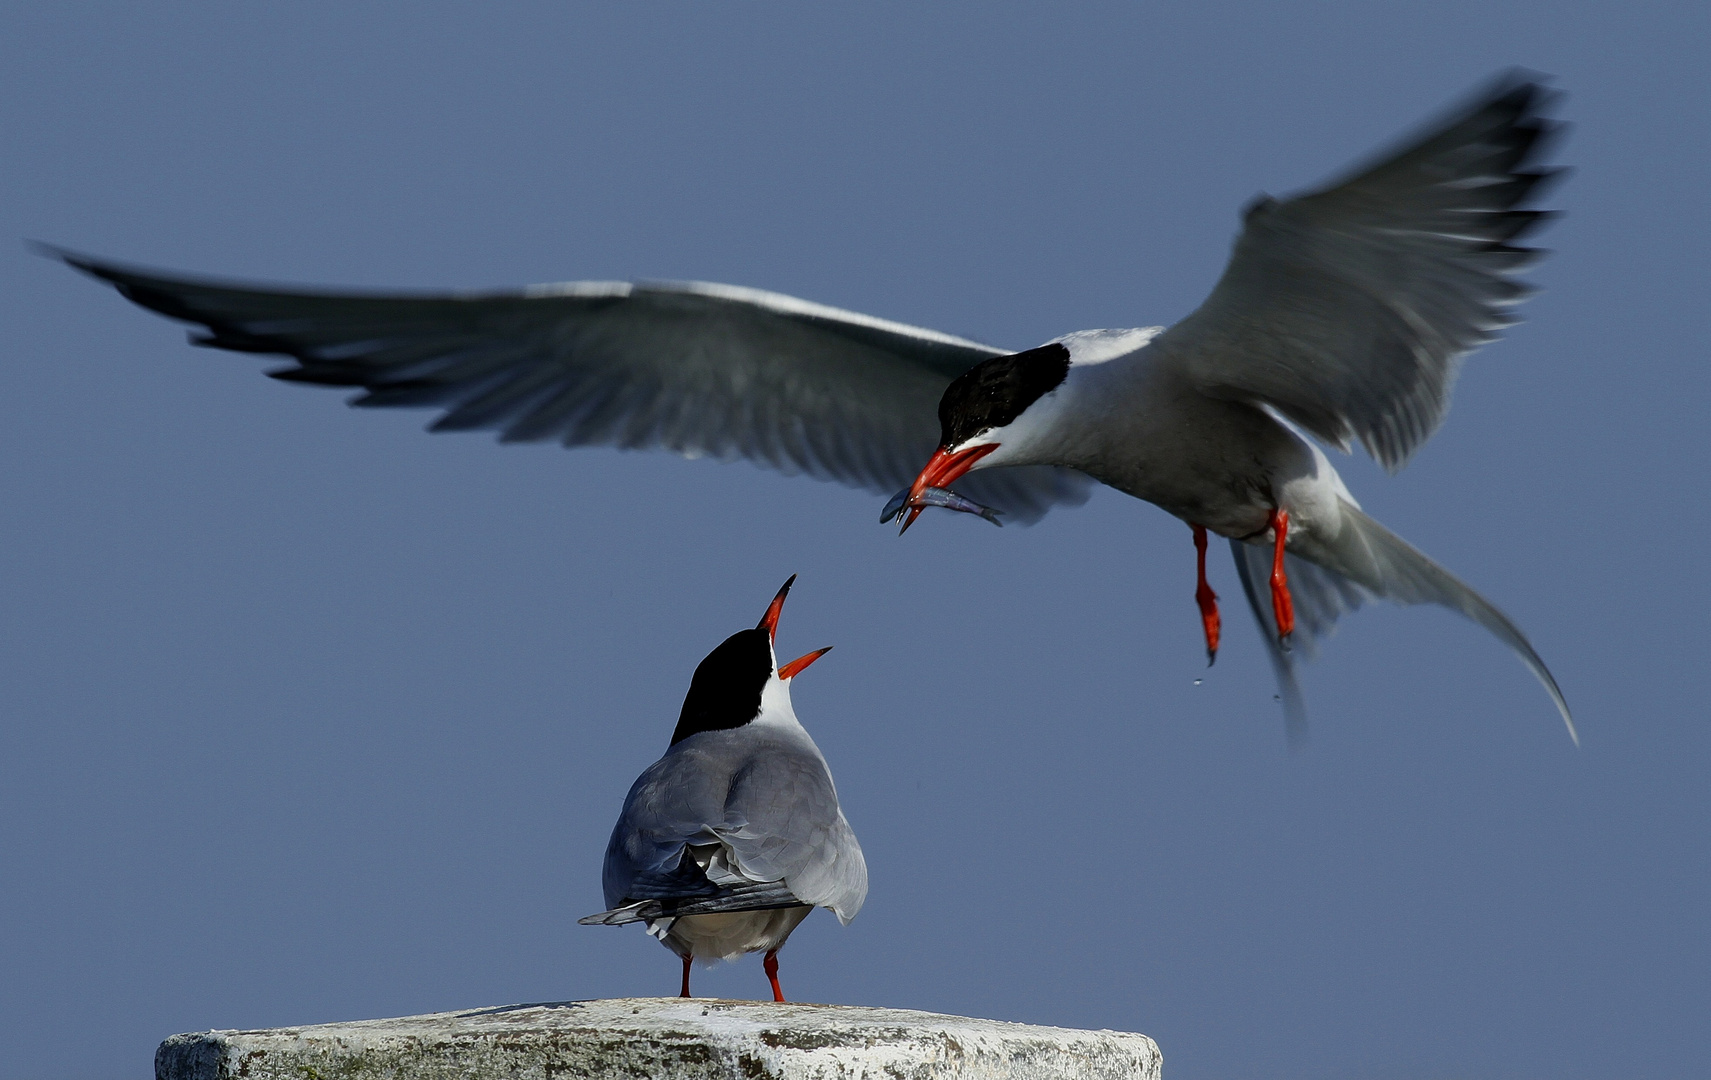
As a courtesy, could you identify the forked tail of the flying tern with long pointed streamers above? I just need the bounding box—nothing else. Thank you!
[1230,500,1581,746]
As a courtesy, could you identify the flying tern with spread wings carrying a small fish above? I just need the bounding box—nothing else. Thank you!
[50,74,1578,741]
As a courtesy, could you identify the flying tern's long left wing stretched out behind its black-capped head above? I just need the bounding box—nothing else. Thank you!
[53,252,1090,522]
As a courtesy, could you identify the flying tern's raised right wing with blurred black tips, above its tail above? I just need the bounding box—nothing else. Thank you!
[1153,72,1559,472]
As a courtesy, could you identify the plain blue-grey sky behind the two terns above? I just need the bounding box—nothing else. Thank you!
[0,0,1711,1080]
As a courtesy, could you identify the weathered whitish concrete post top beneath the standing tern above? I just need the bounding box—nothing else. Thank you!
[154,998,1160,1080]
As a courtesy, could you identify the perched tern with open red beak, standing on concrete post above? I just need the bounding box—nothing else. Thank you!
[580,575,867,1001]
